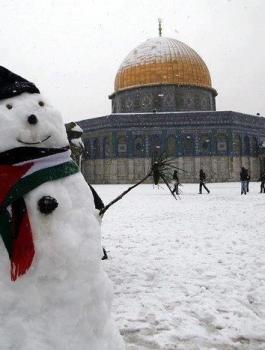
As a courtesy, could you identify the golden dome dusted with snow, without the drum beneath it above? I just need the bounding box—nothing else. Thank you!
[115,37,212,92]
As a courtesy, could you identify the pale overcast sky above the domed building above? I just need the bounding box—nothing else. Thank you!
[0,0,265,121]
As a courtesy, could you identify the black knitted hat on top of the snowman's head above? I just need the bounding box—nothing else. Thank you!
[0,66,40,100]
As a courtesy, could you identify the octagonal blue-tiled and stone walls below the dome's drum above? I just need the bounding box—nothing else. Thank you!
[77,111,265,183]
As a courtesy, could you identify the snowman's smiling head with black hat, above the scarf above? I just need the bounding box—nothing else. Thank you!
[0,67,68,152]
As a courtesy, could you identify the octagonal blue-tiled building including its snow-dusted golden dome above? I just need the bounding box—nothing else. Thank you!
[78,37,265,183]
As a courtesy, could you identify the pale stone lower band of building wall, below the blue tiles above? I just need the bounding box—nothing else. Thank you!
[82,156,260,184]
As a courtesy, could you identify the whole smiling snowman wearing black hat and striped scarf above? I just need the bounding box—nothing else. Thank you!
[0,67,124,350]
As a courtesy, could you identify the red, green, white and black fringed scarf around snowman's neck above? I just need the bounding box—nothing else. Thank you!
[0,147,79,281]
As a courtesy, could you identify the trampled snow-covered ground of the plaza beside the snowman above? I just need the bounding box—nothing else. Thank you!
[95,183,265,350]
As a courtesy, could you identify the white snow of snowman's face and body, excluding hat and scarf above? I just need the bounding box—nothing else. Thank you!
[0,93,124,350]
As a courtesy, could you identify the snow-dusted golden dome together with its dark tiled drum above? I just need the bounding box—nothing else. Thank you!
[110,37,217,113]
